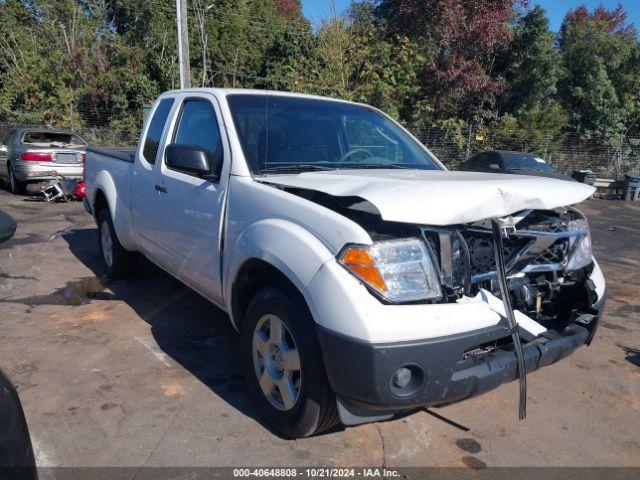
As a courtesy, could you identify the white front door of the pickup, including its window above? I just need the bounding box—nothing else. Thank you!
[156,94,229,302]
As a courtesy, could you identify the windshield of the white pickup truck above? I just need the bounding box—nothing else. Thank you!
[228,94,440,174]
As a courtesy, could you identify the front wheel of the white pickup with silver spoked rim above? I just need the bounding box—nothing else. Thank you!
[241,288,338,438]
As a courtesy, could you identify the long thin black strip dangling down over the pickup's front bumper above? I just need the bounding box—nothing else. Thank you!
[491,219,527,420]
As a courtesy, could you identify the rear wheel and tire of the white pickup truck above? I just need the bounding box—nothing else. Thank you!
[98,208,138,280]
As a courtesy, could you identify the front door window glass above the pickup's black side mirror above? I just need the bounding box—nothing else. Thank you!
[173,99,222,174]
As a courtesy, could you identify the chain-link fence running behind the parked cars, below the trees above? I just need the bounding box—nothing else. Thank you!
[0,111,640,178]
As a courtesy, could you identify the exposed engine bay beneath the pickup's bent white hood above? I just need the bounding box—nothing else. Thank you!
[284,187,597,331]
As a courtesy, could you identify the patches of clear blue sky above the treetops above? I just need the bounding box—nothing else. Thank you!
[302,0,640,32]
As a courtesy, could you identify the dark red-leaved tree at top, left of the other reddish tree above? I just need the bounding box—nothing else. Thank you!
[377,0,524,120]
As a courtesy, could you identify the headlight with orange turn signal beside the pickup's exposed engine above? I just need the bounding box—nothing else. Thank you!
[338,238,442,302]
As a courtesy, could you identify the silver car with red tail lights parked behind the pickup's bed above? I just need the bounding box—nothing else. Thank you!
[0,128,87,194]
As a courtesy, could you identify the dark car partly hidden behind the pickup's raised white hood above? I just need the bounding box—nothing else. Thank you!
[458,150,575,182]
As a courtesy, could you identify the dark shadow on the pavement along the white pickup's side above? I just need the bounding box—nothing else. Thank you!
[61,228,284,430]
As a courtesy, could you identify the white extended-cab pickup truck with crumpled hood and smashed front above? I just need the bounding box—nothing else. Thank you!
[85,89,605,437]
